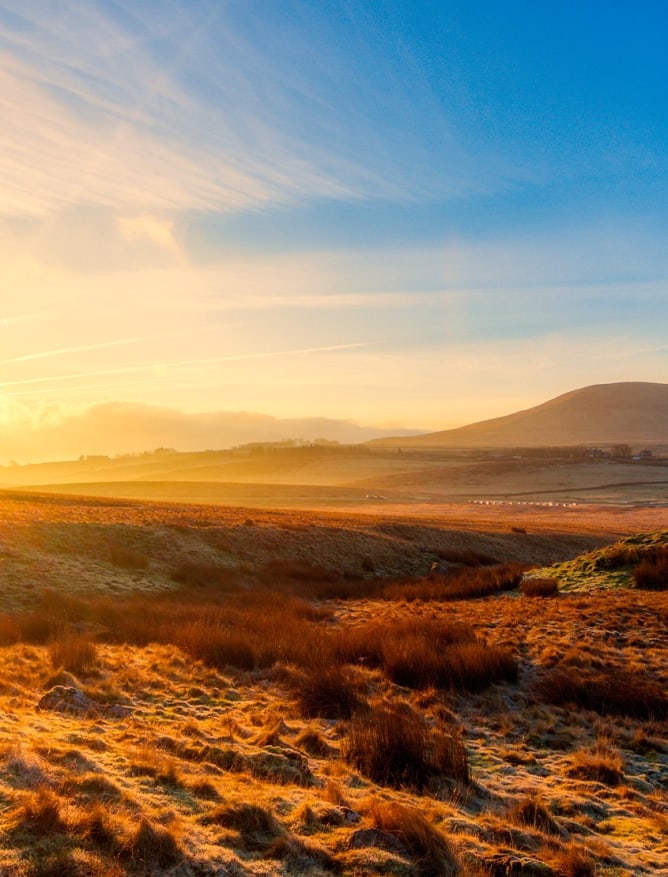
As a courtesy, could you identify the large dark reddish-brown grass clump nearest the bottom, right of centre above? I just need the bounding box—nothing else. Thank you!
[342,705,470,791]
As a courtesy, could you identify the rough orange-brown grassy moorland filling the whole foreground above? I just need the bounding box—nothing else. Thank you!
[0,490,668,877]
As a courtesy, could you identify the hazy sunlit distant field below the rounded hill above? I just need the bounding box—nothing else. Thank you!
[5,449,668,514]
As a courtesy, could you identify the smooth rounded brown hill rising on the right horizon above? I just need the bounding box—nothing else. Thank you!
[372,381,668,448]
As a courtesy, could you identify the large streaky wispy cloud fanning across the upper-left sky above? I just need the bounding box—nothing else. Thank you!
[0,2,505,221]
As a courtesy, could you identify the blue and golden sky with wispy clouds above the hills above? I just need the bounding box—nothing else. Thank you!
[0,0,668,462]
